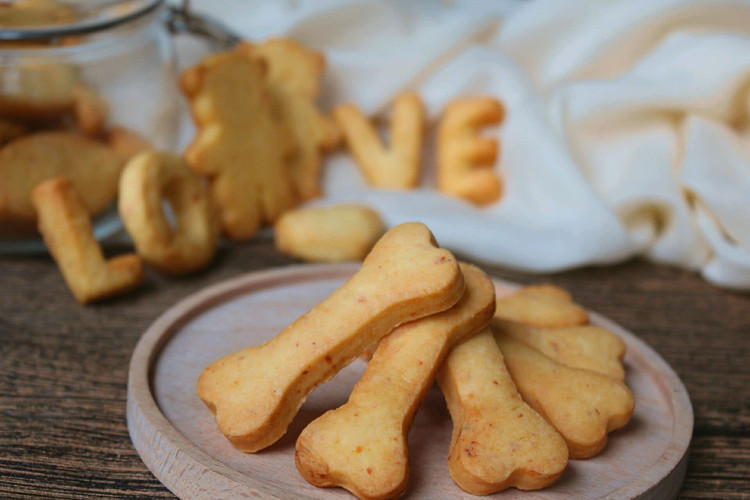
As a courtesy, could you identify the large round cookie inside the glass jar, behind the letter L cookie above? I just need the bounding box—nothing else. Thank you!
[0,132,121,234]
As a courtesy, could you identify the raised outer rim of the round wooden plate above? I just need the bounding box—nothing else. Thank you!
[126,263,694,500]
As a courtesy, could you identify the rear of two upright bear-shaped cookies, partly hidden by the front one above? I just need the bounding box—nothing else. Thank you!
[247,38,341,200]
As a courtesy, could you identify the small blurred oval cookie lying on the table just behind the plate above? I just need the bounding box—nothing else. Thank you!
[274,205,385,262]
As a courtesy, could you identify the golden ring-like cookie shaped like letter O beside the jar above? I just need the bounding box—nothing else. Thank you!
[119,151,219,274]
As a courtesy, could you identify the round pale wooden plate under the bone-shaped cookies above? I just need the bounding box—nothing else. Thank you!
[127,265,693,499]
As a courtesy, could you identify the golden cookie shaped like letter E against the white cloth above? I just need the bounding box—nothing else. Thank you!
[438,97,505,205]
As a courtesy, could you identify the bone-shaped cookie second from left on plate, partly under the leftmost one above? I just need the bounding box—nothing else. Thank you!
[295,264,495,499]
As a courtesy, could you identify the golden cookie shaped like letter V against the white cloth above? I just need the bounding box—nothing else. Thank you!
[333,92,424,189]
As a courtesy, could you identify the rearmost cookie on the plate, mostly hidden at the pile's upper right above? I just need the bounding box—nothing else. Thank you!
[495,285,589,328]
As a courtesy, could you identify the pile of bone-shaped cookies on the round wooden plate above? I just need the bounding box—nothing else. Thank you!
[197,223,634,499]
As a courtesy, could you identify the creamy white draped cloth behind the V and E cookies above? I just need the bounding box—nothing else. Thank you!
[194,0,750,290]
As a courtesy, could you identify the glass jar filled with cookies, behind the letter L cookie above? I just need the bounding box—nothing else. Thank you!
[0,0,181,242]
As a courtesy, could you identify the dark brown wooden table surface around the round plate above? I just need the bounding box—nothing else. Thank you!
[0,238,750,499]
